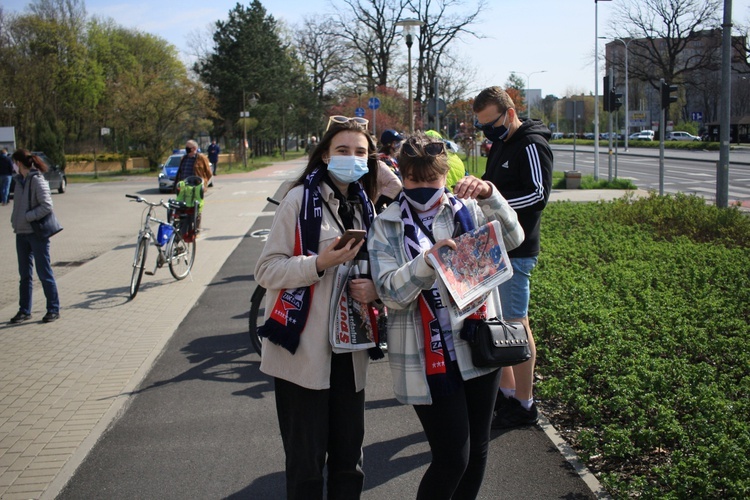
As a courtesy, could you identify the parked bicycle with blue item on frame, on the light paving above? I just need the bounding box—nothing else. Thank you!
[125,194,198,299]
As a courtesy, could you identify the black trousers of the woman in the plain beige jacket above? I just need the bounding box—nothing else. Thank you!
[275,354,365,500]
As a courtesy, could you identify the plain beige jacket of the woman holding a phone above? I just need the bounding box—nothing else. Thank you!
[255,182,369,391]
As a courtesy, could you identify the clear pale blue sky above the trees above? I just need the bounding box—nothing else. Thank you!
[3,0,750,97]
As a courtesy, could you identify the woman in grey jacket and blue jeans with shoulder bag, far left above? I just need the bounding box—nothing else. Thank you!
[10,149,60,323]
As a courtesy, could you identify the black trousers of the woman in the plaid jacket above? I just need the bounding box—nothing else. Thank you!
[414,370,500,500]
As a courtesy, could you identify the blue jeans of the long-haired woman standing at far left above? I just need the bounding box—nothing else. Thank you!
[16,233,60,314]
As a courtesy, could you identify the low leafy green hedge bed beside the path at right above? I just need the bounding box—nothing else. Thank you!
[530,195,750,499]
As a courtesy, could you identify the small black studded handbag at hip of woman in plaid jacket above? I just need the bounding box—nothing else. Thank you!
[461,318,531,368]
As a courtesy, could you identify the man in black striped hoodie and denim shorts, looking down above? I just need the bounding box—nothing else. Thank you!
[474,87,553,429]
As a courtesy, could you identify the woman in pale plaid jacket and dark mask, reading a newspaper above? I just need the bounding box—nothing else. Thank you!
[367,133,523,500]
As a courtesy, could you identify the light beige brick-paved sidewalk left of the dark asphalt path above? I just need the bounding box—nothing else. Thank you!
[0,160,642,500]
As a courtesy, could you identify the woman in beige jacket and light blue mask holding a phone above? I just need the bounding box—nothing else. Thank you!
[255,116,378,499]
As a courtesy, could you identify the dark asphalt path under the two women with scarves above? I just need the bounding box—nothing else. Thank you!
[58,184,596,499]
